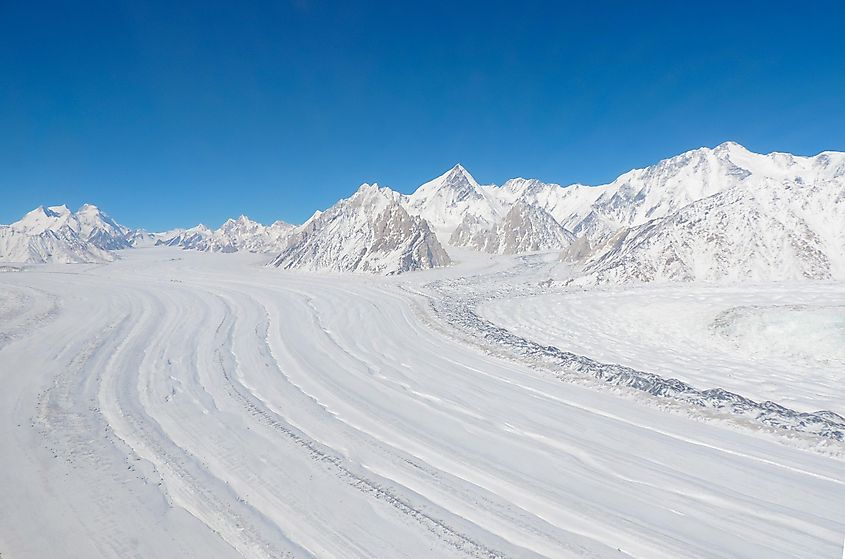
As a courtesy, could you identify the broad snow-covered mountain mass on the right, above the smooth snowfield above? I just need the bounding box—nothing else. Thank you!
[574,143,845,283]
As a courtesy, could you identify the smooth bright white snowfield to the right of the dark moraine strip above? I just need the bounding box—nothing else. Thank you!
[480,282,845,415]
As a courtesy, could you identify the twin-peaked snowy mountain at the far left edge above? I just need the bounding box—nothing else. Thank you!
[0,204,131,263]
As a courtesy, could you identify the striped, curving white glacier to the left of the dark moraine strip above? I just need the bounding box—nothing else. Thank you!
[0,249,845,559]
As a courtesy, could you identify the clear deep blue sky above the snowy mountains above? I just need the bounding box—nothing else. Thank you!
[0,0,845,230]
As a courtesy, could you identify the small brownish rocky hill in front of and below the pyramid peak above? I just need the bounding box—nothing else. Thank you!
[449,201,575,254]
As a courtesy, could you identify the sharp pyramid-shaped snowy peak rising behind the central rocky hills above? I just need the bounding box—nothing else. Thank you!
[402,164,504,240]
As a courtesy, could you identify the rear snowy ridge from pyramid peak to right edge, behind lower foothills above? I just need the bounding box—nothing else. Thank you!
[404,142,845,258]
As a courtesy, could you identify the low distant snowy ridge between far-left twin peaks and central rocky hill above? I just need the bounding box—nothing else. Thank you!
[156,215,293,253]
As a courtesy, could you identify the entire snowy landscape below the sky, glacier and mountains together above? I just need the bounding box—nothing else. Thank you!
[0,142,845,559]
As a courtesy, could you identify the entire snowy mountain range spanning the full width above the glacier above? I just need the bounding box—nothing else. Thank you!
[0,142,845,283]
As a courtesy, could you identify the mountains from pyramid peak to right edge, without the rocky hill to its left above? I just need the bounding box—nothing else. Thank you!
[406,142,845,283]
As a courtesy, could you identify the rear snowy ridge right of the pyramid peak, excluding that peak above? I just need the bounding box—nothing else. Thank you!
[454,142,845,253]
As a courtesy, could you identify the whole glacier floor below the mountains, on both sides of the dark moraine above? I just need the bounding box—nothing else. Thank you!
[0,248,845,559]
